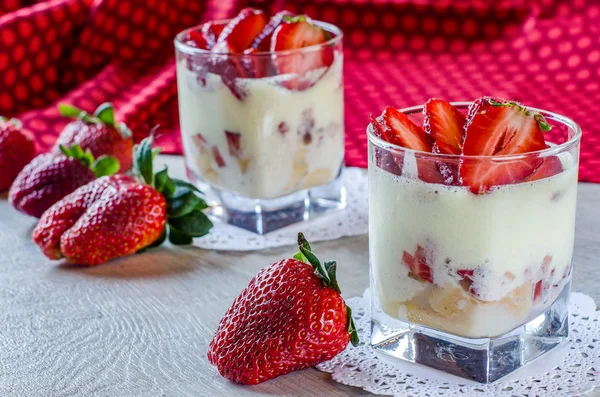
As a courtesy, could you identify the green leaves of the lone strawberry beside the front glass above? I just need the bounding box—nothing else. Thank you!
[294,233,359,346]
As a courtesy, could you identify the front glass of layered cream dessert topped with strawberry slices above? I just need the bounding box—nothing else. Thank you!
[367,97,581,383]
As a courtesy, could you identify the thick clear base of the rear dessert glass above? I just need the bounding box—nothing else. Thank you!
[187,168,346,234]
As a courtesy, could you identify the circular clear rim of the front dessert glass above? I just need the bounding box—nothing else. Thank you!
[367,101,582,162]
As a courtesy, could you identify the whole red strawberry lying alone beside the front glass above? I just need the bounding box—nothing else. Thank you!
[208,233,358,384]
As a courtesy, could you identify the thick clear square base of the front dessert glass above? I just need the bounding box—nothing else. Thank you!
[371,282,571,383]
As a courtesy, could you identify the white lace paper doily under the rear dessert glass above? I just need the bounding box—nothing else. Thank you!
[194,168,369,251]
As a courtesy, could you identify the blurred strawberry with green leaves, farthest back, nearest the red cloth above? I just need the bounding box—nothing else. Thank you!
[53,103,133,173]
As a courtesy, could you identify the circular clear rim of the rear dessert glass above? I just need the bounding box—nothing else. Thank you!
[174,19,344,58]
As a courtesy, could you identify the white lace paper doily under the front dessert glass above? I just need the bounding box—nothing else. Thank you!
[317,290,600,397]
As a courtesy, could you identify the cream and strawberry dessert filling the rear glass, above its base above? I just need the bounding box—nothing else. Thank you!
[176,8,344,199]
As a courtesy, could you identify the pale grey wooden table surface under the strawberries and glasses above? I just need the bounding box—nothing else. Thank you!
[0,157,600,397]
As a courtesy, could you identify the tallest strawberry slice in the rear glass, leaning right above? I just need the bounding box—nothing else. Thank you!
[217,8,269,53]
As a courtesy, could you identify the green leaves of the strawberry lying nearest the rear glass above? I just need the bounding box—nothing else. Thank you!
[134,137,213,245]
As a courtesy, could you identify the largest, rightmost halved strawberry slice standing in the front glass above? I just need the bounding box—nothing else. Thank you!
[460,98,550,194]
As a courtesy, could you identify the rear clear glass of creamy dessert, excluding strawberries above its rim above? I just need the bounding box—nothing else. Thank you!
[175,21,345,234]
